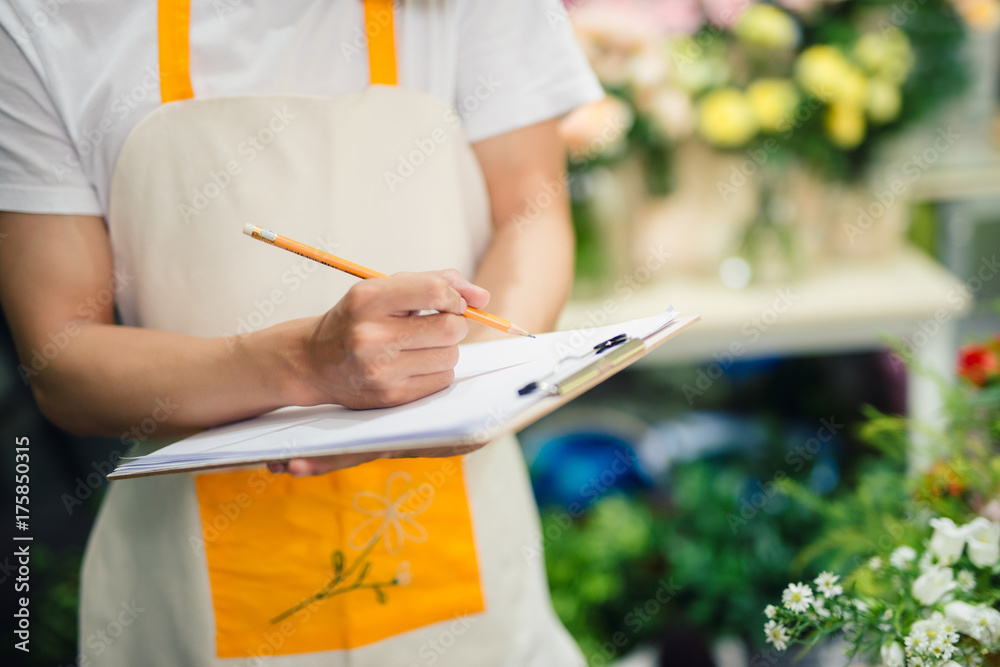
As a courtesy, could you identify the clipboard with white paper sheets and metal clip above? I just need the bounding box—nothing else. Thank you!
[108,309,701,480]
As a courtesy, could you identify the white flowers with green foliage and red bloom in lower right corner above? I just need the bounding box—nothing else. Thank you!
[764,337,1000,667]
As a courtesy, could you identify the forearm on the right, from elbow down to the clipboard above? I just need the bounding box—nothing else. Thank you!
[466,210,573,342]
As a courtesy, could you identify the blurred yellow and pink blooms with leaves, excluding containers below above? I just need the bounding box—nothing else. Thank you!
[564,0,980,185]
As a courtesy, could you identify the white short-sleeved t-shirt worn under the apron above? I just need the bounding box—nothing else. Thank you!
[0,0,603,216]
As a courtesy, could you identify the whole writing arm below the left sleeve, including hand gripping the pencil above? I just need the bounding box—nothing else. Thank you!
[0,213,488,448]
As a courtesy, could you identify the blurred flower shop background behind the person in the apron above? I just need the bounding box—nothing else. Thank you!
[0,0,1000,667]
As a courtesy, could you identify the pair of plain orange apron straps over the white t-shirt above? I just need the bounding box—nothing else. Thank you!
[157,0,396,104]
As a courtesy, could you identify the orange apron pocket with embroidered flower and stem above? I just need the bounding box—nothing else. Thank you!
[195,457,484,658]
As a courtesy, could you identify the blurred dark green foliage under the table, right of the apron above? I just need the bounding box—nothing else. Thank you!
[543,448,815,654]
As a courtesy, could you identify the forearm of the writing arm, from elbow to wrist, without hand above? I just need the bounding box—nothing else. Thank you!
[21,318,315,438]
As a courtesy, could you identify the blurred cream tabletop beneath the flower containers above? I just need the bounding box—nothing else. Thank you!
[558,248,971,363]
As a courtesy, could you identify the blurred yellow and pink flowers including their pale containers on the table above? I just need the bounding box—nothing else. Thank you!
[563,0,988,287]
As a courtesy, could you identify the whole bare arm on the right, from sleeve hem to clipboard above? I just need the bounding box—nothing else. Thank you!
[466,120,573,342]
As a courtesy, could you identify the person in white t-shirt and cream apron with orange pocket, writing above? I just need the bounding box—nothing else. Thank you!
[0,0,602,667]
